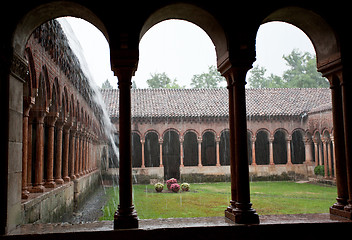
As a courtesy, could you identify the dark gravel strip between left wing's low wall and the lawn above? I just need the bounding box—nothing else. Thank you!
[69,186,107,224]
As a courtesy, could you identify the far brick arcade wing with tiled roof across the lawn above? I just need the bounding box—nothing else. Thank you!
[101,88,335,181]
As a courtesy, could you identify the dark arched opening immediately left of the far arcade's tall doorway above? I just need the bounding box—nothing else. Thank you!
[144,132,160,167]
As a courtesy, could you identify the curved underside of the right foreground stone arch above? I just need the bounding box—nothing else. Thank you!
[263,7,341,70]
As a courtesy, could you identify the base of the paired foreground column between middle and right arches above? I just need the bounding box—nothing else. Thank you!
[225,203,260,224]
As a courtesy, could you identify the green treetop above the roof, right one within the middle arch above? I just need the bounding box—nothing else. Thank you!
[191,66,226,88]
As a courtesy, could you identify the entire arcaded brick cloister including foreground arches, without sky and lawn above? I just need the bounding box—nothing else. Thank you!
[0,0,352,240]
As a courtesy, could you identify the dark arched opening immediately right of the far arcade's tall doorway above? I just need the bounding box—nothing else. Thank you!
[183,131,198,166]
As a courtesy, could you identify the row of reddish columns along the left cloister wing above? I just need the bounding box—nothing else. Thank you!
[22,105,98,199]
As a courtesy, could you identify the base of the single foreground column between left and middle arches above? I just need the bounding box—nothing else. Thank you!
[114,205,139,230]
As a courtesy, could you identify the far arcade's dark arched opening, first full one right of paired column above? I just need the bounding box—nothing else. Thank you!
[255,130,269,165]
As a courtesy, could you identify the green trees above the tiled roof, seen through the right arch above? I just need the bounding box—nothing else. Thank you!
[248,49,329,88]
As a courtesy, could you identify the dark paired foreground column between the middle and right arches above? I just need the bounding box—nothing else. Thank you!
[222,62,259,224]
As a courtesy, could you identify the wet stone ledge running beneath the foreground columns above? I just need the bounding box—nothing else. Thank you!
[10,213,352,235]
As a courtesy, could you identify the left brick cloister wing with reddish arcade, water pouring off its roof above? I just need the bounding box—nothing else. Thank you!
[20,20,105,223]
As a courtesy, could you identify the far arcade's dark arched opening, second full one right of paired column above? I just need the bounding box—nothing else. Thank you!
[273,130,287,164]
